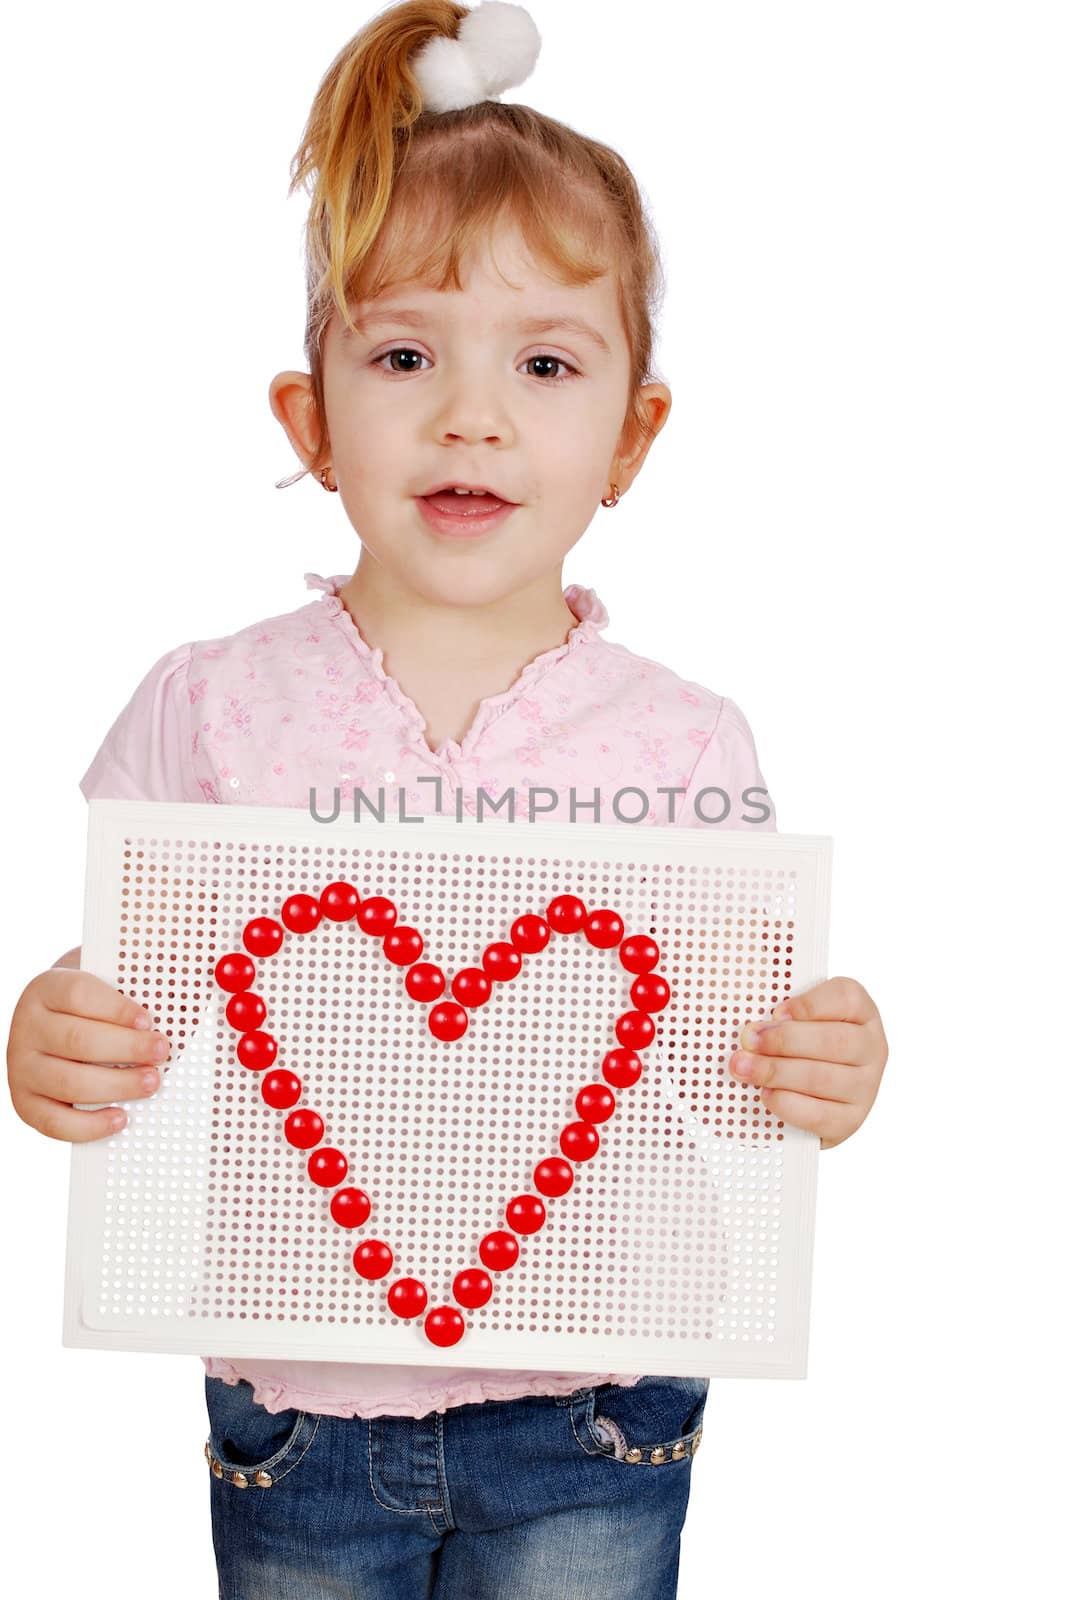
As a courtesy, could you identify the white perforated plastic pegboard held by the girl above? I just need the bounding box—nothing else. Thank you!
[64,800,831,1378]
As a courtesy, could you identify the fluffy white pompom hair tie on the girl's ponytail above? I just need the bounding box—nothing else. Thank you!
[413,0,543,110]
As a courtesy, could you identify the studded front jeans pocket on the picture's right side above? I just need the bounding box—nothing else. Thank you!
[572,1378,709,1467]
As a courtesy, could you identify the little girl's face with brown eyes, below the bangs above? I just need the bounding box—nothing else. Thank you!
[272,216,669,605]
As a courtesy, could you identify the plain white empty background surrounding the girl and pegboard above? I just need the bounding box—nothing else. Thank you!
[0,0,1071,1600]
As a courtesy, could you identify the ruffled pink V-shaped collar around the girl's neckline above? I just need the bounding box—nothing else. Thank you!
[304,573,610,766]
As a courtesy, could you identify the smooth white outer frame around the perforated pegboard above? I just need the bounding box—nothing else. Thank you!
[64,800,832,1378]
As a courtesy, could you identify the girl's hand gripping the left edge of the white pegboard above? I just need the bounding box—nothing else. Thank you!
[8,966,170,1144]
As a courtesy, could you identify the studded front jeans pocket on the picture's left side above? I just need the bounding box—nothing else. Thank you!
[205,1374,322,1490]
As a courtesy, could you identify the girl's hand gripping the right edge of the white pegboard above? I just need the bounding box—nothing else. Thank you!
[728,978,888,1150]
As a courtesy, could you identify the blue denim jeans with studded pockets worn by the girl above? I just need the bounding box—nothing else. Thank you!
[205,1376,708,1600]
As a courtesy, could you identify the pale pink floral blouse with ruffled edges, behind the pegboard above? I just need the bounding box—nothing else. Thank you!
[80,573,776,1418]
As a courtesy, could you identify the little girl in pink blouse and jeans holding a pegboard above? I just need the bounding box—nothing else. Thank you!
[8,0,887,1600]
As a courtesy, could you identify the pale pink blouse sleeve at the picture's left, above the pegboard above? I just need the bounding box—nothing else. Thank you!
[78,645,205,802]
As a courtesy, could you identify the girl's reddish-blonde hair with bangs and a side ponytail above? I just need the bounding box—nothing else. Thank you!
[277,0,664,488]
